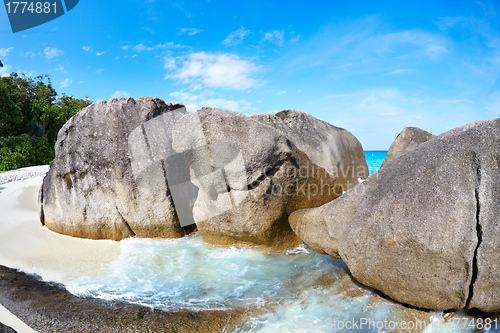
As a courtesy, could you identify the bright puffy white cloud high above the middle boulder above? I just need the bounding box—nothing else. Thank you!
[164,52,258,90]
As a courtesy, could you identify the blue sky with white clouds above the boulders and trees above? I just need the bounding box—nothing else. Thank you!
[0,0,500,150]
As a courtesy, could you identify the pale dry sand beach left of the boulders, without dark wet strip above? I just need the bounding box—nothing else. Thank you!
[0,165,120,333]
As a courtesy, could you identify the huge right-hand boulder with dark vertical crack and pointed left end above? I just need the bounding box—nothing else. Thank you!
[290,119,500,312]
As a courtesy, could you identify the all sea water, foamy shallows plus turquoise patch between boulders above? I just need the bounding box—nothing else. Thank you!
[66,151,499,333]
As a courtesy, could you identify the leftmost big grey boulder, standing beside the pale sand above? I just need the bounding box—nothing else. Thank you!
[39,97,192,240]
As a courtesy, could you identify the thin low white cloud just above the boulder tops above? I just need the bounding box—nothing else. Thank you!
[170,91,252,112]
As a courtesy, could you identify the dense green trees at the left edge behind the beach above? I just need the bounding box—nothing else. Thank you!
[0,73,91,171]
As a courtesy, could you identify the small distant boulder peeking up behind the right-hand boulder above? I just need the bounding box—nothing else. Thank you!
[382,127,434,166]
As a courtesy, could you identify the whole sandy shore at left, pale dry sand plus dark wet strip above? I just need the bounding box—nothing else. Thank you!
[0,166,263,333]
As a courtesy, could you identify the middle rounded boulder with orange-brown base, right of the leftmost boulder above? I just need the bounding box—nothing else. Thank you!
[173,108,367,249]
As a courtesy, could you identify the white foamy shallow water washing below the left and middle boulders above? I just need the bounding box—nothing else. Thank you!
[67,235,335,308]
